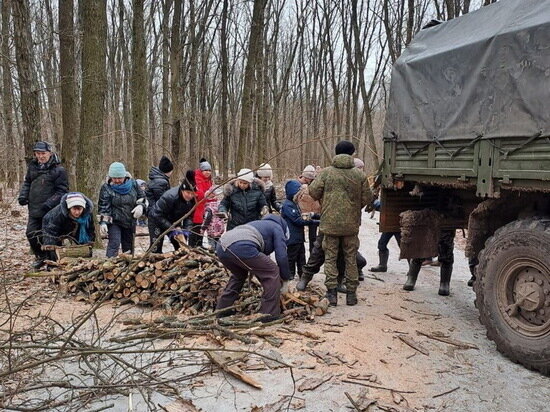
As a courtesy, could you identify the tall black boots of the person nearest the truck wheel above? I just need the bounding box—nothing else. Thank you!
[403,230,455,296]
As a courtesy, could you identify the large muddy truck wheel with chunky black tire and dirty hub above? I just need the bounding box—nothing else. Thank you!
[474,218,550,375]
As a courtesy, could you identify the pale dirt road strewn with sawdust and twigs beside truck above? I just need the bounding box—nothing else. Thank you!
[1,206,550,412]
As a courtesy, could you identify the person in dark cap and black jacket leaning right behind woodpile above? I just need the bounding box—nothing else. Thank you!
[149,179,196,253]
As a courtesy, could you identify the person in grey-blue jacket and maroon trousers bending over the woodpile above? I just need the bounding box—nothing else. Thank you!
[216,214,290,321]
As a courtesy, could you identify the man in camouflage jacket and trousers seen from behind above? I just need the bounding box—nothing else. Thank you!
[309,140,372,306]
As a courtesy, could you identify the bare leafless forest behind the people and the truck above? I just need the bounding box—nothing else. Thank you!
[0,0,495,198]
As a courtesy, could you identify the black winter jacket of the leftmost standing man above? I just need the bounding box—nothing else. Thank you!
[18,153,69,218]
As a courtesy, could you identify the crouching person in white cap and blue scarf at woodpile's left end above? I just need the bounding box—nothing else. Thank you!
[42,192,95,260]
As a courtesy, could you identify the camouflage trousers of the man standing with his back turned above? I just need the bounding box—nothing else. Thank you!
[323,235,359,292]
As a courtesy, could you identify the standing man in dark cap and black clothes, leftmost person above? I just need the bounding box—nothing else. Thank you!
[18,142,69,269]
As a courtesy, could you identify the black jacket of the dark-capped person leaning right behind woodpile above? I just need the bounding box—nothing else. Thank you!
[149,186,195,232]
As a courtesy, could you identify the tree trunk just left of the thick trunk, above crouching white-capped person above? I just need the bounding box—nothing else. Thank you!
[59,0,78,187]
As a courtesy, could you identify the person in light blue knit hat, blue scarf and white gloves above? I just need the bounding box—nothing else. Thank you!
[98,162,147,257]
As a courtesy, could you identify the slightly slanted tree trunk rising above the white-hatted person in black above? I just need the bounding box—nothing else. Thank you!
[235,0,267,169]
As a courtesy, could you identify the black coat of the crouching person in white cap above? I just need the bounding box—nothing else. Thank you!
[42,195,95,246]
